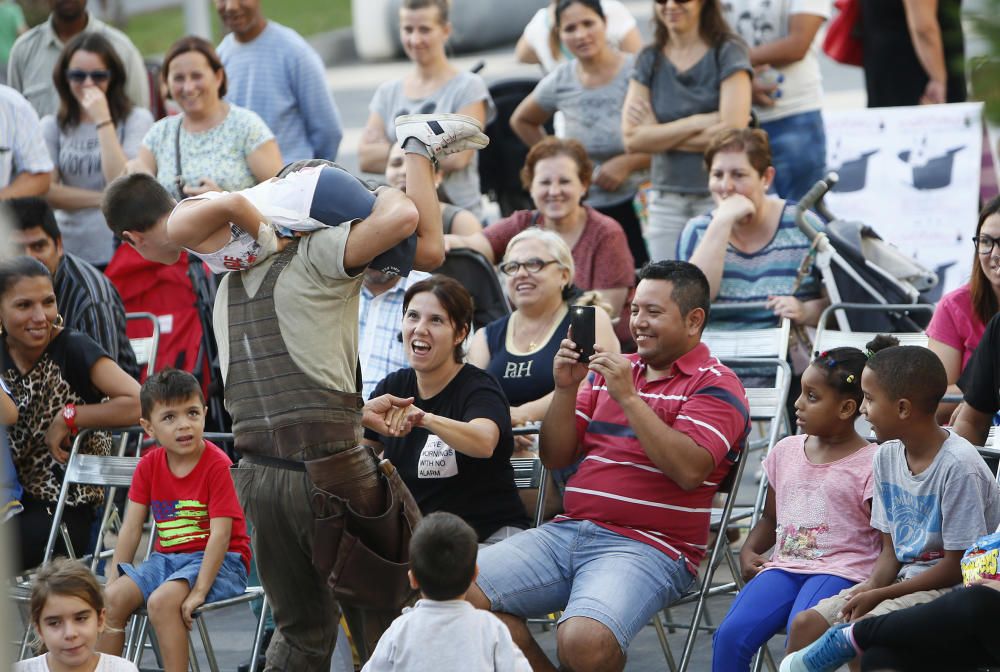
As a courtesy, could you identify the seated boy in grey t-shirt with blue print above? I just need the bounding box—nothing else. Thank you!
[782,336,1000,670]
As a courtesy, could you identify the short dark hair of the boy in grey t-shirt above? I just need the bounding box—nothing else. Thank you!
[865,334,948,415]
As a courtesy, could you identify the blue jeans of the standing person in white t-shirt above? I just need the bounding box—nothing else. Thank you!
[760,110,826,201]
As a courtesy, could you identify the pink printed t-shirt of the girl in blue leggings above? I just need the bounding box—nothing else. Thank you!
[764,434,882,582]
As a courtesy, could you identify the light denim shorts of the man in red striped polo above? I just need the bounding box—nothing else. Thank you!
[476,520,694,653]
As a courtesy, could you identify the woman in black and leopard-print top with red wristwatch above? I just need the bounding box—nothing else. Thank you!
[0,257,139,569]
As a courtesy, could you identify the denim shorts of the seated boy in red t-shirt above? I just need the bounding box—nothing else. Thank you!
[118,551,247,602]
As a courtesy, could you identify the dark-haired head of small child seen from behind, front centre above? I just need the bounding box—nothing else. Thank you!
[410,511,479,600]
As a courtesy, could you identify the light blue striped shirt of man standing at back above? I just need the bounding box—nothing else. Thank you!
[219,20,344,163]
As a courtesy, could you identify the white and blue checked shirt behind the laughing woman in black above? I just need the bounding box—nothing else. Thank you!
[358,271,430,399]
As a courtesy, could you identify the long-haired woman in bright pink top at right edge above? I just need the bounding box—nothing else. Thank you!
[927,196,1000,425]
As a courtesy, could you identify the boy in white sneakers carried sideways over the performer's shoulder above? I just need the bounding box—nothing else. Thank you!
[101,114,489,275]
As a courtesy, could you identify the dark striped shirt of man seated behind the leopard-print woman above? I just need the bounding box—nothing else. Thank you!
[52,252,139,378]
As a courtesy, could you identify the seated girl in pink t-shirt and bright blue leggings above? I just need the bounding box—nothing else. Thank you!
[712,348,882,672]
